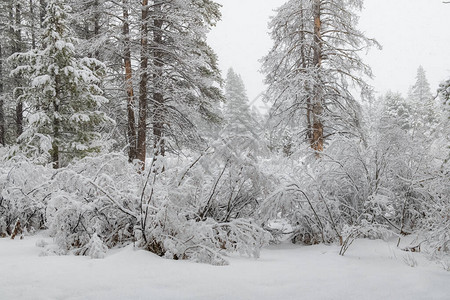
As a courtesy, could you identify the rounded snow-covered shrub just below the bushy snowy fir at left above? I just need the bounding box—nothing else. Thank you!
[47,154,142,254]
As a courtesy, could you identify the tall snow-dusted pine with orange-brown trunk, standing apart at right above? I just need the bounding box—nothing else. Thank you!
[263,0,377,153]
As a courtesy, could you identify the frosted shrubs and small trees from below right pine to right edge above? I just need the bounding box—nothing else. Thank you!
[261,87,450,254]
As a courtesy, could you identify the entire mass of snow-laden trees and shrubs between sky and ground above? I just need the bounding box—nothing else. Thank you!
[0,0,450,274]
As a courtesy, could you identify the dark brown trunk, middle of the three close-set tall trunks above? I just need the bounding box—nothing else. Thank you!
[136,0,149,168]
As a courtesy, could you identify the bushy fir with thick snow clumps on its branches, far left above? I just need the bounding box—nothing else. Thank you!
[11,0,110,168]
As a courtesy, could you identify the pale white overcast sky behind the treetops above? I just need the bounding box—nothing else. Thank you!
[209,0,450,105]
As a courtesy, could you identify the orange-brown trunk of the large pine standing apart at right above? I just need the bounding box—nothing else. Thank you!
[311,0,323,157]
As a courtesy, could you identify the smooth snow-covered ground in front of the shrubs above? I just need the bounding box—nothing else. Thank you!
[0,234,450,300]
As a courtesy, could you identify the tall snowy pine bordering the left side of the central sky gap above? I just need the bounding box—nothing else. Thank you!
[148,0,223,155]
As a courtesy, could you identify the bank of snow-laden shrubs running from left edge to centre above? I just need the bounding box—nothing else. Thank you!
[0,150,268,264]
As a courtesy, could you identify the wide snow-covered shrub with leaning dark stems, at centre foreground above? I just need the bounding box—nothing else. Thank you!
[132,148,268,264]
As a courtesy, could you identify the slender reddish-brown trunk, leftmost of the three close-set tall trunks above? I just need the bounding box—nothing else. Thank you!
[122,0,136,162]
